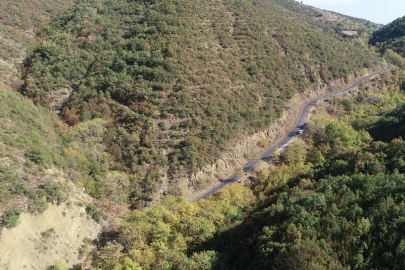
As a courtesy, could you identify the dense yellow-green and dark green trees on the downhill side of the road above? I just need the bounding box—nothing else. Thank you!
[93,65,405,270]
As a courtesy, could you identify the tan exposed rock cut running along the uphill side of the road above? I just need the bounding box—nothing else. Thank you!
[183,66,383,199]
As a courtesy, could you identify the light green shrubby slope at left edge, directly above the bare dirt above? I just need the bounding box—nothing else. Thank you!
[0,88,67,226]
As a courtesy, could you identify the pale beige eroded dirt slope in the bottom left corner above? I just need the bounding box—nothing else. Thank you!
[0,184,102,270]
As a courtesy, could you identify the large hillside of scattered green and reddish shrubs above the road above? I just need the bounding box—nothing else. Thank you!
[22,0,380,205]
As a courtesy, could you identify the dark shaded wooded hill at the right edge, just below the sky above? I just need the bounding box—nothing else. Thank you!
[370,16,405,57]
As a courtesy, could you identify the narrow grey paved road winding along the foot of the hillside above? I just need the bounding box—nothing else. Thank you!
[190,64,392,201]
